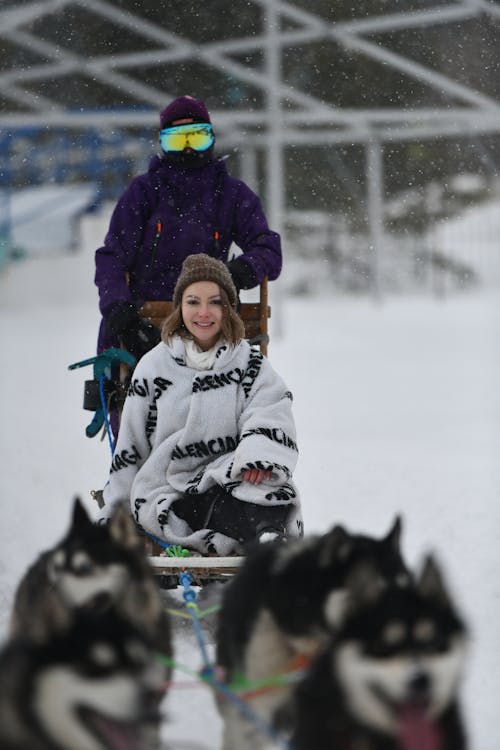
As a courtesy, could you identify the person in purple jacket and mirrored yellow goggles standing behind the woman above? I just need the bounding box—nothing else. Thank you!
[95,96,281,368]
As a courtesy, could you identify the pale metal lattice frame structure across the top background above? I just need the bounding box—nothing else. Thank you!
[0,0,500,292]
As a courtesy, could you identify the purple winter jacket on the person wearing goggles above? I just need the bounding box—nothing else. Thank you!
[95,155,281,351]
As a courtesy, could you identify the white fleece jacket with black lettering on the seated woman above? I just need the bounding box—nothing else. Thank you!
[100,336,302,554]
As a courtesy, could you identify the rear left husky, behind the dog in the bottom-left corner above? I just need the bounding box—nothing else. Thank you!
[11,498,172,668]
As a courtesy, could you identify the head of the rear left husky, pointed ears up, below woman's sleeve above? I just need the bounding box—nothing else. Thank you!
[46,498,150,608]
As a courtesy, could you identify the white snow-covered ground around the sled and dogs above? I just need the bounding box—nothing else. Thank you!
[0,214,500,750]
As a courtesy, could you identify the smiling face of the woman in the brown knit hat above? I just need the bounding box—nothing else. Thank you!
[181,281,223,351]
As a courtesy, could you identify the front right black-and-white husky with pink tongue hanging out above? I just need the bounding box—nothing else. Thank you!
[292,557,466,750]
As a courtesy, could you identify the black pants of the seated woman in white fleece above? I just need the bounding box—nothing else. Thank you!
[171,487,292,544]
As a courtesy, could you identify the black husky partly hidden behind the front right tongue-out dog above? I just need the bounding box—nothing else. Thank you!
[217,518,410,750]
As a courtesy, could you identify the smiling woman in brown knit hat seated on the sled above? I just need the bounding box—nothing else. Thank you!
[97,253,302,555]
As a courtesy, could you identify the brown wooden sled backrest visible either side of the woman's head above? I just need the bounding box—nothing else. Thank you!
[139,278,271,355]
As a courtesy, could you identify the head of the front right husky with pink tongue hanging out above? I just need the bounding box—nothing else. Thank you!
[330,557,465,747]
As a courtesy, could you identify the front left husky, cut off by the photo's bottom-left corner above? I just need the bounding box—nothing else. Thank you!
[0,610,163,750]
